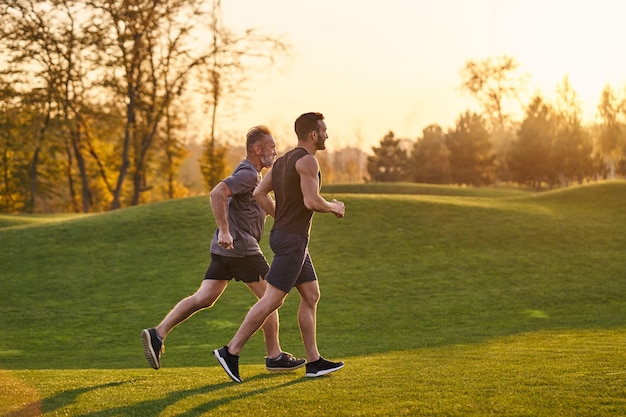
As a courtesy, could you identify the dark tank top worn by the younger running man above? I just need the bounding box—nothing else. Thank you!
[272,148,321,235]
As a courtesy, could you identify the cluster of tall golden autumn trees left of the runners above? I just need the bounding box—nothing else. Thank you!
[0,0,289,212]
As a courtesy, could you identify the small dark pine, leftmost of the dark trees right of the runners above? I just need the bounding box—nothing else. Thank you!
[367,131,410,182]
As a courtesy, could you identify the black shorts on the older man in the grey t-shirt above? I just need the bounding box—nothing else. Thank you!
[204,253,269,282]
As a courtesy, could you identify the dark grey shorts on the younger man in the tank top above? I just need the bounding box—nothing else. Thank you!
[265,230,317,293]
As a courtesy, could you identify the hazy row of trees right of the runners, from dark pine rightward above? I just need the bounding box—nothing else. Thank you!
[367,56,626,188]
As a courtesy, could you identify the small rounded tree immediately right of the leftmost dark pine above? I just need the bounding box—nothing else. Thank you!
[411,125,452,184]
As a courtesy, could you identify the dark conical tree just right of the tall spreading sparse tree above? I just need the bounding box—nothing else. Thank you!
[508,95,557,188]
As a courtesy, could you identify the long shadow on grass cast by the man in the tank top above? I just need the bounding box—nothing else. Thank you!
[72,374,306,417]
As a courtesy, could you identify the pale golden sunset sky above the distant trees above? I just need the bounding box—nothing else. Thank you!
[213,0,626,151]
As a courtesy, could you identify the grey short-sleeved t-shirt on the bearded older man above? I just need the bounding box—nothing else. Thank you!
[211,159,266,257]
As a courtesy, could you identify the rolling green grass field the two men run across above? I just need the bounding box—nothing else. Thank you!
[0,181,626,417]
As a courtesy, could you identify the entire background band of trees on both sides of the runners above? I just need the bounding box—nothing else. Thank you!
[0,14,626,212]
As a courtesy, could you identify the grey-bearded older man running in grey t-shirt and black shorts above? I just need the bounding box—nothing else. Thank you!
[141,126,305,371]
